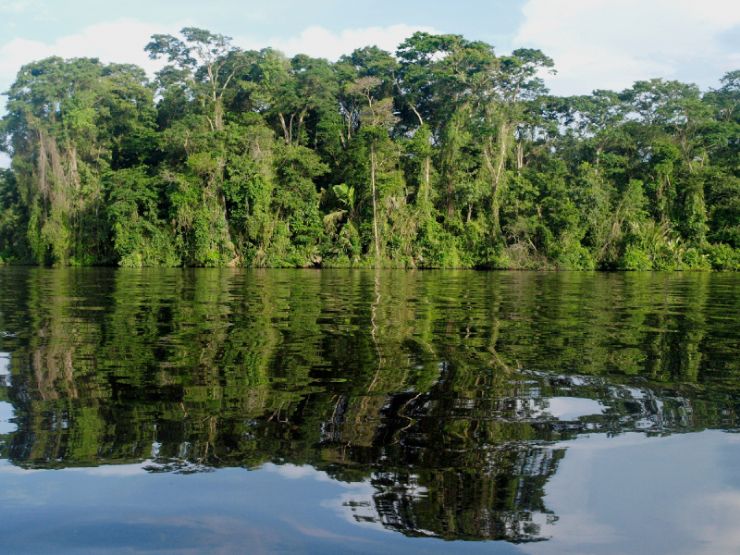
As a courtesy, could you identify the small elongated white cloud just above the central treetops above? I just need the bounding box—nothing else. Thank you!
[237,24,437,60]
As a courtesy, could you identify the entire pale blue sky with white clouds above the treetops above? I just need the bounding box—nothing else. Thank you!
[0,0,740,97]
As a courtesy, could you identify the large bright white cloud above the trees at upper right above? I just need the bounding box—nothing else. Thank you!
[513,0,740,94]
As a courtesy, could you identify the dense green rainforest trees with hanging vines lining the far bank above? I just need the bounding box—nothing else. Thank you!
[0,28,740,270]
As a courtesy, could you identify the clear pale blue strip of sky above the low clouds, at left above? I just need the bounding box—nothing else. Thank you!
[0,0,524,40]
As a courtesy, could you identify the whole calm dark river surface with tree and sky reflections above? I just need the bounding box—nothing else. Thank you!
[0,268,740,554]
